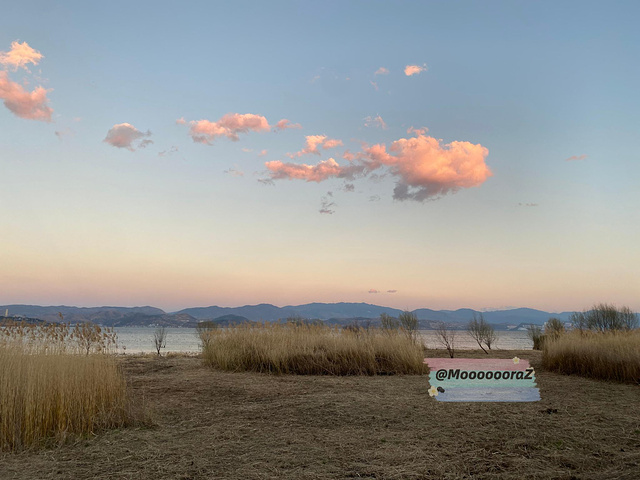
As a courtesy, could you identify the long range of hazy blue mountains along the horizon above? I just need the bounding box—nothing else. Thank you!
[0,303,573,328]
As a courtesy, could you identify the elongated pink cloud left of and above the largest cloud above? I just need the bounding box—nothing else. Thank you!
[189,113,270,145]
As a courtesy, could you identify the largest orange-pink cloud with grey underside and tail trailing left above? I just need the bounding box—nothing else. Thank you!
[265,130,492,201]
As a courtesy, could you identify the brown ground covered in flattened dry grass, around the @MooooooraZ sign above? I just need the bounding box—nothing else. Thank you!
[0,351,640,480]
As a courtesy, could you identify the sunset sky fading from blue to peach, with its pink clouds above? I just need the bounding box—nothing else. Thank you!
[0,0,640,312]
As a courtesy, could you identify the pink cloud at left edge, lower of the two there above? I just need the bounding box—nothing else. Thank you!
[0,71,53,122]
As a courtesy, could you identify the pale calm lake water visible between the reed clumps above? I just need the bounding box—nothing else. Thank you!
[115,327,532,353]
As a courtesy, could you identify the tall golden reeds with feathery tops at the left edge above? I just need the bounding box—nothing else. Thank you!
[0,324,132,451]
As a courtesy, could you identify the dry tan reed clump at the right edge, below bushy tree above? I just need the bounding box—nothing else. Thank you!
[542,330,640,384]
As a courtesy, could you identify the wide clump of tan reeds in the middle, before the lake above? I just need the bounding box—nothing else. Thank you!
[202,323,426,375]
